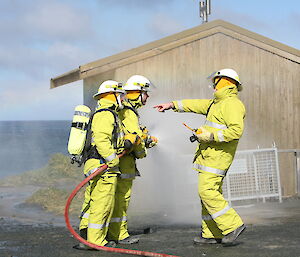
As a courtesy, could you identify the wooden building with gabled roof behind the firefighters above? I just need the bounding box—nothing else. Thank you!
[51,20,300,196]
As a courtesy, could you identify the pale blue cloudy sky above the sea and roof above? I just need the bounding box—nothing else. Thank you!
[0,0,300,121]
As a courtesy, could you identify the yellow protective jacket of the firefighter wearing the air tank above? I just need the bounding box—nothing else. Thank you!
[84,99,124,175]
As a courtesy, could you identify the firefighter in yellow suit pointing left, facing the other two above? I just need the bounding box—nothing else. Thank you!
[154,69,246,244]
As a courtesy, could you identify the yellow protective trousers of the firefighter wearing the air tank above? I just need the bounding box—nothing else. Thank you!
[79,171,118,246]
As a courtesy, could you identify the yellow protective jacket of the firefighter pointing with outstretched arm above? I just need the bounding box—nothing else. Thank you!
[173,85,245,176]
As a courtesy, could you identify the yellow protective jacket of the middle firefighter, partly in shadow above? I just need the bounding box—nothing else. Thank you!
[119,102,146,178]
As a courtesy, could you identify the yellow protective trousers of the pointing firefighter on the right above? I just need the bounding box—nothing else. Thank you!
[198,170,243,238]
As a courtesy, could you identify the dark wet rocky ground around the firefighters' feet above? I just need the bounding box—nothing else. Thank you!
[0,184,300,257]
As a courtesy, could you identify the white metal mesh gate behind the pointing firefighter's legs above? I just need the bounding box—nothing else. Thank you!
[223,148,282,202]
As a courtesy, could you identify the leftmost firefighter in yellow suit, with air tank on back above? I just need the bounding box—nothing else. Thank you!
[74,80,124,249]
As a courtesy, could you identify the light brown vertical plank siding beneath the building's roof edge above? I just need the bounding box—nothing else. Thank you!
[84,33,300,195]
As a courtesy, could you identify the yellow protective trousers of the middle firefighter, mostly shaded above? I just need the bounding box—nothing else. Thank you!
[108,175,133,240]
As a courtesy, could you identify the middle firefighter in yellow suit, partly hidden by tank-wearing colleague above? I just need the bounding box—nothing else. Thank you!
[108,75,157,244]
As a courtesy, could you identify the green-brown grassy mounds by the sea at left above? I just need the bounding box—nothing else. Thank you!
[0,153,85,215]
